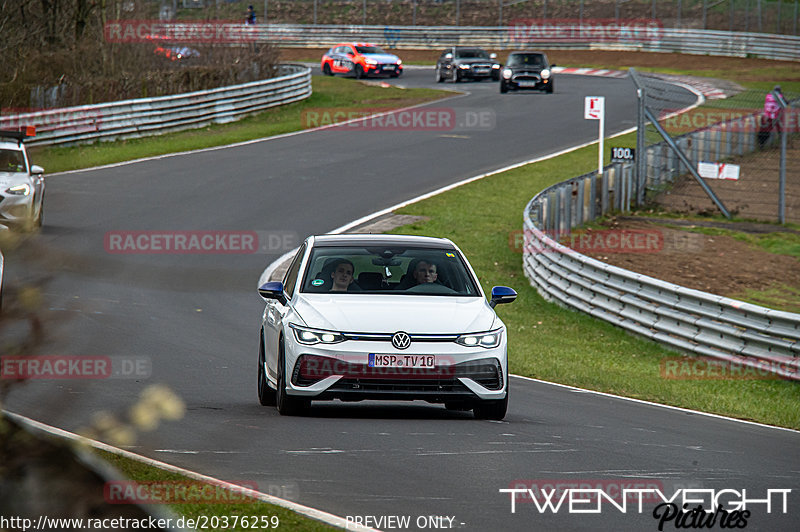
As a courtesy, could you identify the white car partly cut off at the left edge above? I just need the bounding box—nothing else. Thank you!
[0,131,44,229]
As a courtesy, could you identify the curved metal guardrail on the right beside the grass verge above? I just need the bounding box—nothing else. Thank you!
[523,115,800,380]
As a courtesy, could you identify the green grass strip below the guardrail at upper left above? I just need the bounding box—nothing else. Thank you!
[29,76,452,173]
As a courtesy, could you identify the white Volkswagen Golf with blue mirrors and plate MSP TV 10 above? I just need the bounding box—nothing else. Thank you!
[258,235,517,419]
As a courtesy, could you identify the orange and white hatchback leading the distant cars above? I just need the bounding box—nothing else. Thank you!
[320,43,403,78]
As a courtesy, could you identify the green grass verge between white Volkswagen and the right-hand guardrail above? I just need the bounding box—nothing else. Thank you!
[393,140,800,428]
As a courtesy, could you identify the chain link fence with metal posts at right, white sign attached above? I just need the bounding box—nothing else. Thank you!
[634,69,800,222]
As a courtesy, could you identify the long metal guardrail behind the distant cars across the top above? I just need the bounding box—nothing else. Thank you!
[253,24,800,61]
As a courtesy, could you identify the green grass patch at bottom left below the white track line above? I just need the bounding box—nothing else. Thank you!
[96,451,340,532]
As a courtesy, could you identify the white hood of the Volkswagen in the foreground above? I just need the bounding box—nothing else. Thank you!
[295,294,496,334]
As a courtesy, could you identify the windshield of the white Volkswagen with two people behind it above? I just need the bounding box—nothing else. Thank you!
[302,246,480,297]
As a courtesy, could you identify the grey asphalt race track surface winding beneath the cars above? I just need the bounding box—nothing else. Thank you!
[6,69,800,531]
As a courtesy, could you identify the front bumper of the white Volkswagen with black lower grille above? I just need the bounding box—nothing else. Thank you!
[286,334,508,403]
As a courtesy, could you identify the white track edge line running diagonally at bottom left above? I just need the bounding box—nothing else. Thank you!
[5,410,378,532]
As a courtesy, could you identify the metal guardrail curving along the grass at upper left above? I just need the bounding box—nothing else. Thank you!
[0,65,311,146]
